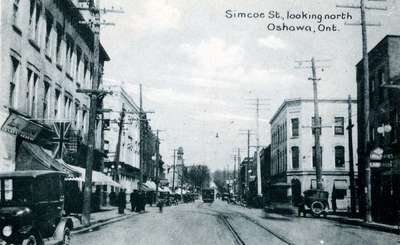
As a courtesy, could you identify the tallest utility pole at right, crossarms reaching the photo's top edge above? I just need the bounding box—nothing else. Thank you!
[336,0,387,223]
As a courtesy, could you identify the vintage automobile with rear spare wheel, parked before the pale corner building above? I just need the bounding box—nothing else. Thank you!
[298,189,329,217]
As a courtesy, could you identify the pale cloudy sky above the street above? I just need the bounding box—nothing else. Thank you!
[97,0,400,170]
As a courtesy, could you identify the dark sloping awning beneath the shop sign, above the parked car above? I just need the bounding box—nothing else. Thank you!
[16,141,80,177]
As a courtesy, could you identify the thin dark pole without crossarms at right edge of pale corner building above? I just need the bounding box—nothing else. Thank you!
[347,95,356,216]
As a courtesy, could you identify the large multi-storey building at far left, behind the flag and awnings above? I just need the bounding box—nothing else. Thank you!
[0,0,109,171]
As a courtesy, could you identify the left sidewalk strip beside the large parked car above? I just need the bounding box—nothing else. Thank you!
[70,206,138,233]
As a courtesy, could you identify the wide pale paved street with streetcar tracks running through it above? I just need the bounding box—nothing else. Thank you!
[72,200,400,245]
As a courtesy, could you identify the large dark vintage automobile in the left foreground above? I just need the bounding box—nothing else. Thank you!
[0,170,73,245]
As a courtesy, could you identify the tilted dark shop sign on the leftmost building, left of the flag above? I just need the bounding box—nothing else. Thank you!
[1,113,43,141]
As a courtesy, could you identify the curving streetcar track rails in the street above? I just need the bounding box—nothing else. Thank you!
[198,205,295,245]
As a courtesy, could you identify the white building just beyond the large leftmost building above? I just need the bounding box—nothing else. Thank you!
[103,85,140,193]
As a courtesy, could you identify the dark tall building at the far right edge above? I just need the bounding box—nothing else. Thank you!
[357,35,400,222]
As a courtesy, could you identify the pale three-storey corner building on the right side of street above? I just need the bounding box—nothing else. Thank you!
[269,99,357,208]
